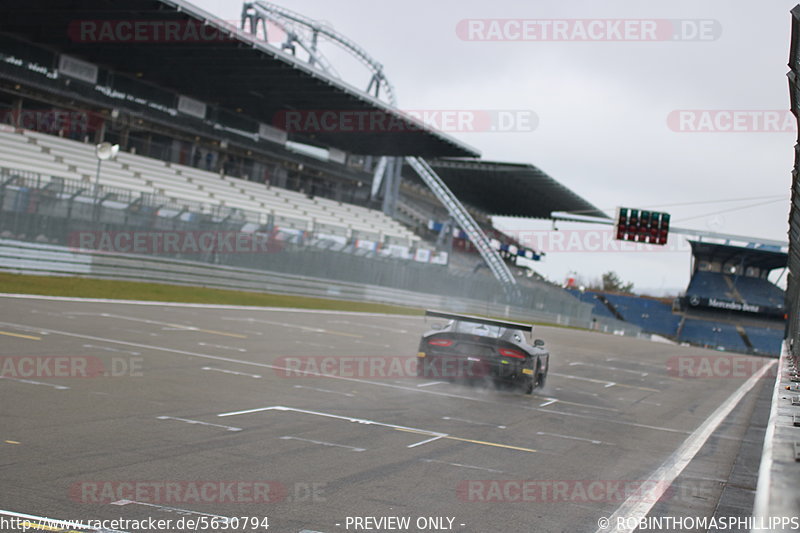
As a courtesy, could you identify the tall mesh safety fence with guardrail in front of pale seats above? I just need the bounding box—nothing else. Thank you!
[0,165,640,335]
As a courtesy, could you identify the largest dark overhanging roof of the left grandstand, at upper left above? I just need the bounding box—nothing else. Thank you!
[2,0,479,157]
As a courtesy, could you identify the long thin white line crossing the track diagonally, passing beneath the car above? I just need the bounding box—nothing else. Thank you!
[0,320,689,434]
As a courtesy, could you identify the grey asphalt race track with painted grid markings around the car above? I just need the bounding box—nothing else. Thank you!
[0,297,771,533]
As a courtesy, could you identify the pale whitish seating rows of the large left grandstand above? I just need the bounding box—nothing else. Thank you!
[0,130,419,245]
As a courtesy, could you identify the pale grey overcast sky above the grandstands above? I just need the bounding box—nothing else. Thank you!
[195,0,796,292]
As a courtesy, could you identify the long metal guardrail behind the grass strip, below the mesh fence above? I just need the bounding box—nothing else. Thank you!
[0,239,641,336]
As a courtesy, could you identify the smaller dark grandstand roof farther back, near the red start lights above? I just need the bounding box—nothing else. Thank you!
[424,159,608,218]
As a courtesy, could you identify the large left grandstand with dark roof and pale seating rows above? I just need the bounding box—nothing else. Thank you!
[0,0,624,331]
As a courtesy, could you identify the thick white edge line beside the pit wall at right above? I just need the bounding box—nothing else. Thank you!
[597,360,776,533]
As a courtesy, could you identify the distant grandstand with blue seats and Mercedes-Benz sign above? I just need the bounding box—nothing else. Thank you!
[568,241,787,355]
